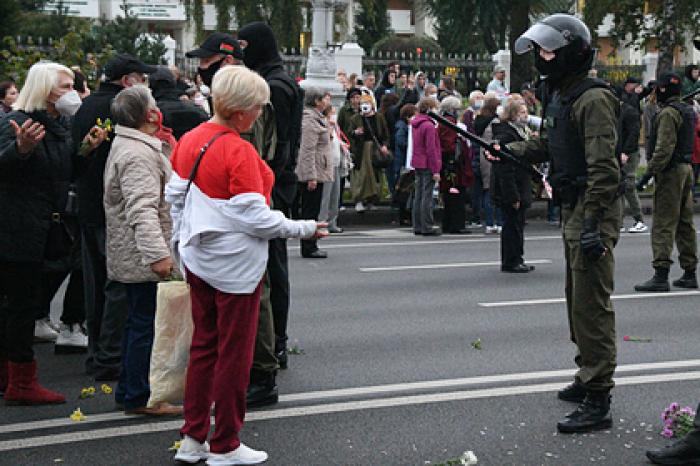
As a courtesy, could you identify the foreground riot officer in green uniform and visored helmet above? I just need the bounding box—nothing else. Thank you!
[492,14,620,433]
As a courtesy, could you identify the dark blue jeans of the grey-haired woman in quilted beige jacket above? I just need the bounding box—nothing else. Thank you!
[115,282,158,410]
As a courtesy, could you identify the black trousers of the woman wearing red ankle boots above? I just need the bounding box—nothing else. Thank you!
[0,262,41,363]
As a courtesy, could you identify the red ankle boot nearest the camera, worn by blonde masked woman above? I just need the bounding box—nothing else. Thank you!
[5,361,66,405]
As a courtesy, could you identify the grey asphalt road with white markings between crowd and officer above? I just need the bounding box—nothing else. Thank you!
[0,217,700,466]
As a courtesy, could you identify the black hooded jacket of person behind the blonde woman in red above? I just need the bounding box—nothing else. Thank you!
[238,22,302,204]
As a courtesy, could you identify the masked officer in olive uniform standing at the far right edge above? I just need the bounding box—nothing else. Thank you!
[634,72,698,292]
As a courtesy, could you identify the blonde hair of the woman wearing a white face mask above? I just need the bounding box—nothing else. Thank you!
[12,61,75,113]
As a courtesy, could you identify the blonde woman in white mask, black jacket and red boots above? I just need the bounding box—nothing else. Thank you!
[0,62,104,405]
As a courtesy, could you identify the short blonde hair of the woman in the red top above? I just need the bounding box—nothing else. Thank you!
[211,66,270,120]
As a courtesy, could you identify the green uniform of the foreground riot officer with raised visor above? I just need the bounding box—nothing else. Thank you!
[508,77,620,391]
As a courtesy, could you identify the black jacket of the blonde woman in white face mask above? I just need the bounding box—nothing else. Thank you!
[0,111,74,263]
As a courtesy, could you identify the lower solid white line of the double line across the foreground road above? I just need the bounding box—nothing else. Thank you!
[0,371,700,451]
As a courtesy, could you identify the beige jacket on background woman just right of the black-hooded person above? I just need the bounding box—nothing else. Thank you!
[296,107,333,183]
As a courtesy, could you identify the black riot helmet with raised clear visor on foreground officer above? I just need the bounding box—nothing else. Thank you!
[515,13,595,83]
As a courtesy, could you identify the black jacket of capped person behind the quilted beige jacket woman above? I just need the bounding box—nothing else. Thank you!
[73,83,123,226]
